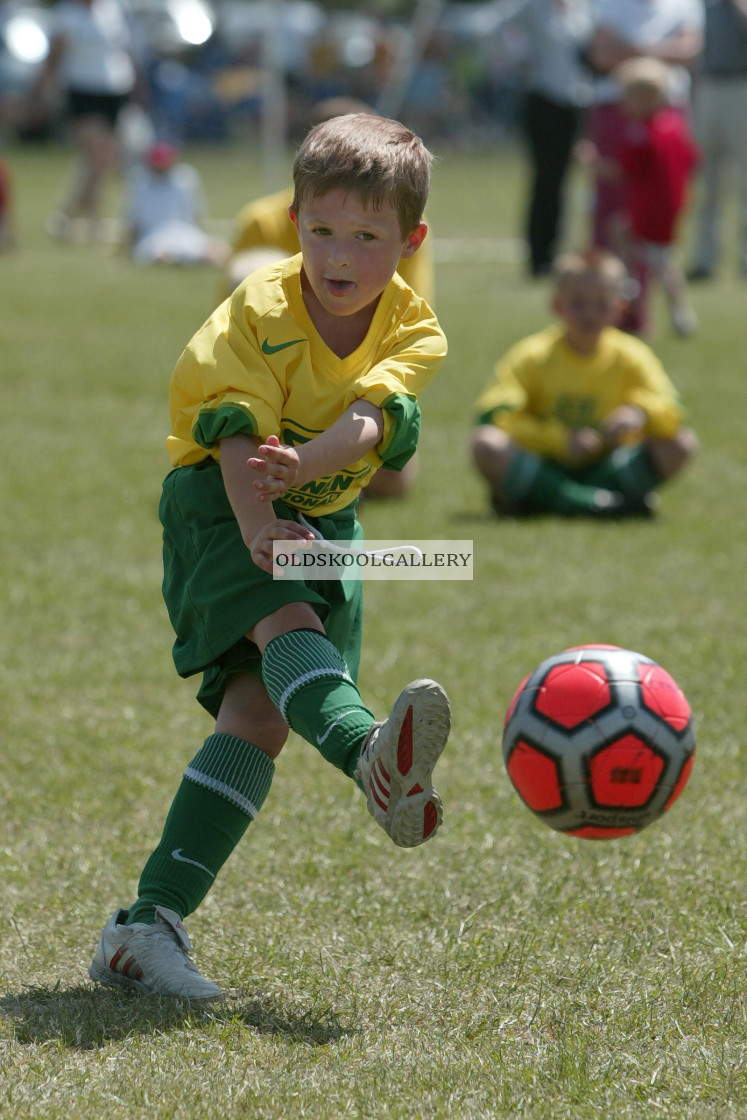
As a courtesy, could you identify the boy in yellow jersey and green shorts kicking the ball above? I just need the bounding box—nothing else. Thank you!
[90,115,450,999]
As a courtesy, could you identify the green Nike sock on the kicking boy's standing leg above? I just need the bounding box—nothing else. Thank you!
[127,734,274,925]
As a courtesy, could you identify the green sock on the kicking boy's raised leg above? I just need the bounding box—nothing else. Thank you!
[262,629,374,777]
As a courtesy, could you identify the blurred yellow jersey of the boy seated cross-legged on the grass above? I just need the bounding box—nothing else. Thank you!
[477,326,683,465]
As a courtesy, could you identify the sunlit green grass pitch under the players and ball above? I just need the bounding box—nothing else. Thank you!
[0,140,747,1120]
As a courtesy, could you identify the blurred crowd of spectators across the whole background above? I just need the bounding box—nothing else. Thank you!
[0,0,747,322]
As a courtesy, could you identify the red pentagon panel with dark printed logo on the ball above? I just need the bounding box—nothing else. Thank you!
[589,735,664,809]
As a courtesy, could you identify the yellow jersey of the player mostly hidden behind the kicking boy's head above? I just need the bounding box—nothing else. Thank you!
[225,189,435,304]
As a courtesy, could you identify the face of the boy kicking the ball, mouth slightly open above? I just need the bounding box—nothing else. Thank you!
[289,189,427,316]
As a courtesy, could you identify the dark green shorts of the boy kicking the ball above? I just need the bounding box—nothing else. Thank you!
[159,458,363,716]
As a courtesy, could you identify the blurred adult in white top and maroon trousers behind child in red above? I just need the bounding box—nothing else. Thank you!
[586,0,703,272]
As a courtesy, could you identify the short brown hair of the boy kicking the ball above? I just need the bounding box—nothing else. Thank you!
[293,113,432,237]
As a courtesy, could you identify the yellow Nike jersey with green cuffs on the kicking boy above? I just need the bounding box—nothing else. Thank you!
[167,253,447,516]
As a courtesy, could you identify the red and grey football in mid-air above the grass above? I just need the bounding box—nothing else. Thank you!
[503,645,695,840]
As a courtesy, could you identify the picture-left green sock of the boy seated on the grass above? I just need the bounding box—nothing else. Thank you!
[501,449,599,516]
